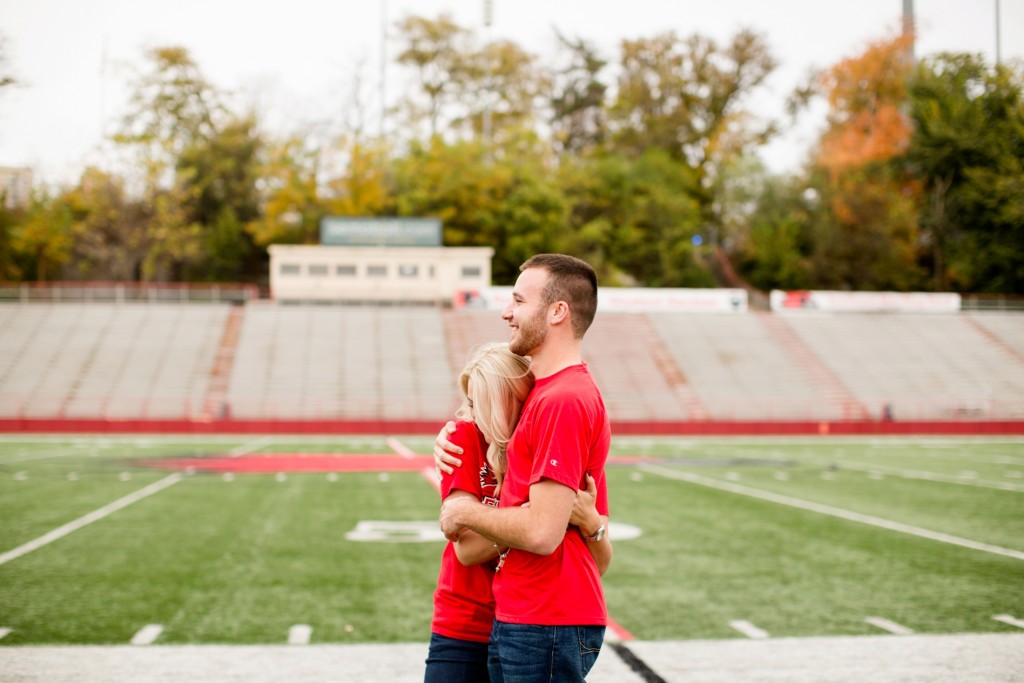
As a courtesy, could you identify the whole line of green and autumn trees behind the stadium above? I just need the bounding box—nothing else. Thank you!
[0,14,1024,293]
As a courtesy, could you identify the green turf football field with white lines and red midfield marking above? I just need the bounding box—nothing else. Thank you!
[0,435,1024,680]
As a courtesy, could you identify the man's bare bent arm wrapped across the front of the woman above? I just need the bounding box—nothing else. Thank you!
[440,479,575,555]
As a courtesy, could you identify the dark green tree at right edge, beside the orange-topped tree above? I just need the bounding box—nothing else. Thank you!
[907,54,1024,293]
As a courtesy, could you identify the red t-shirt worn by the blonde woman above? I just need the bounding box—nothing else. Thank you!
[430,422,498,643]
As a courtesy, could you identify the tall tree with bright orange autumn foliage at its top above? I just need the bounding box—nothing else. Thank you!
[815,35,926,290]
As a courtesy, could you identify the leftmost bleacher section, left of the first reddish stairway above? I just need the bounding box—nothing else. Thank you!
[0,303,227,419]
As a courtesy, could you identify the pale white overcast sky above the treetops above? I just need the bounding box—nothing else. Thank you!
[0,0,1024,187]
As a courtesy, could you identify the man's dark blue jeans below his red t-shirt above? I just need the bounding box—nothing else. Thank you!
[487,622,604,683]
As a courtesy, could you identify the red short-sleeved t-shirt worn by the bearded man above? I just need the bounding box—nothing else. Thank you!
[494,364,611,626]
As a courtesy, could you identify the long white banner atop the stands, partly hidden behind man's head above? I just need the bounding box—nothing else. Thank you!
[463,287,748,313]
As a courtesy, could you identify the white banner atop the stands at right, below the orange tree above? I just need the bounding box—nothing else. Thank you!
[769,290,961,313]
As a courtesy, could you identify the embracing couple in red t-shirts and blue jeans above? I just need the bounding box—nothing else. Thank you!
[425,254,611,683]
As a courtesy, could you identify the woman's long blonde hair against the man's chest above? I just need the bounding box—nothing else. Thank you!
[455,342,534,488]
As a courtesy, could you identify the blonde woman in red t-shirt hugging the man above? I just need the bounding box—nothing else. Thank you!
[424,343,610,683]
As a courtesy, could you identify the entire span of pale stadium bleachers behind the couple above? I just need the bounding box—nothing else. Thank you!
[0,301,1024,423]
